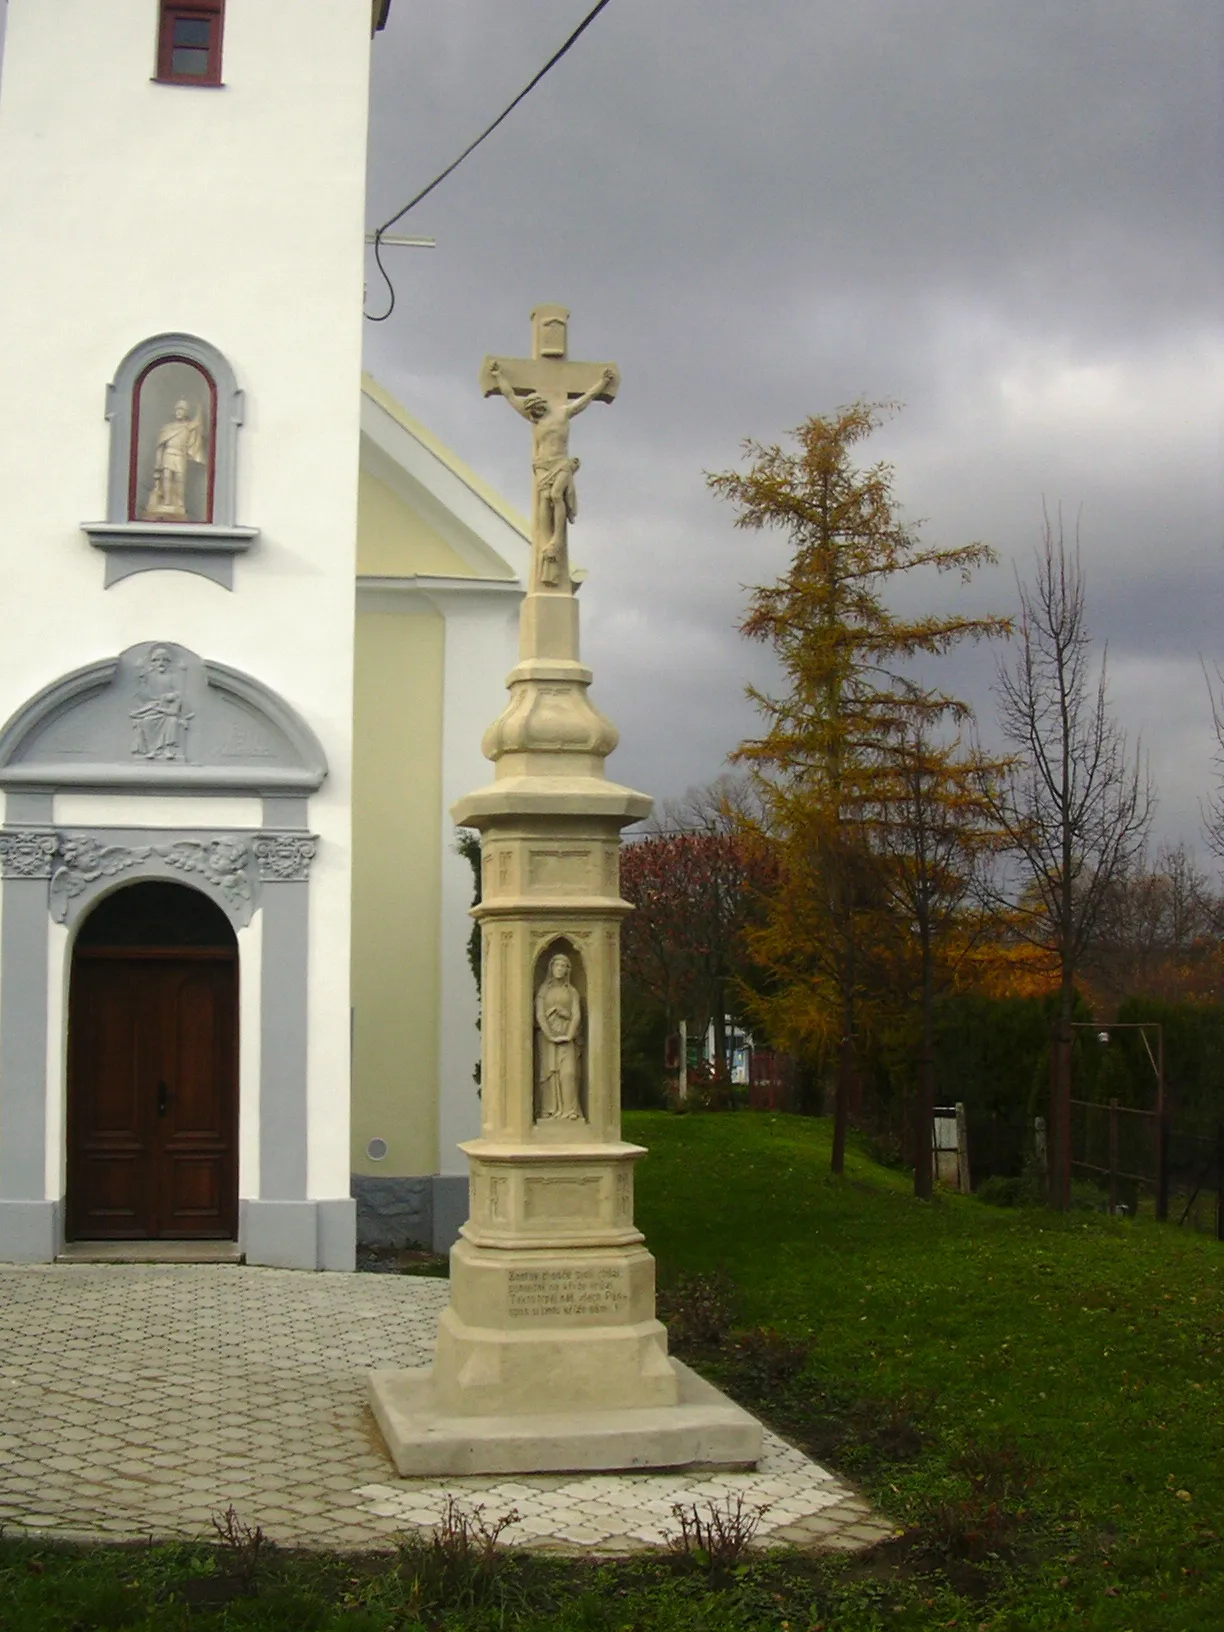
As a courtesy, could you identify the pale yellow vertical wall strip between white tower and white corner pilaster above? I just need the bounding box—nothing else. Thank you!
[353,602,446,1177]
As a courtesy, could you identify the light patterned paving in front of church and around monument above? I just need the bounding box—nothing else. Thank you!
[0,1263,891,1554]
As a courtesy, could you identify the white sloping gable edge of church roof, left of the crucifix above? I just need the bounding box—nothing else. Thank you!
[361,374,530,583]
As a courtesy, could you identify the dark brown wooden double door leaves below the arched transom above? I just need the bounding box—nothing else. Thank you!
[67,945,238,1240]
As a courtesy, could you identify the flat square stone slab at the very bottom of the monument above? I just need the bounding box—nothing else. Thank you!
[367,1359,762,1479]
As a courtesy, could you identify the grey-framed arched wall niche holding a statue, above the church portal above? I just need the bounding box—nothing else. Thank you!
[82,335,259,589]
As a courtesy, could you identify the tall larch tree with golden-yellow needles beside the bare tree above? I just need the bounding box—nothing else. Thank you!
[707,401,1010,1188]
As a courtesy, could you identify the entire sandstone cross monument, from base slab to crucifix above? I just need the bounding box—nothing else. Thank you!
[370,305,761,1474]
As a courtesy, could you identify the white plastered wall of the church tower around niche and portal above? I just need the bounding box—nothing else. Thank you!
[0,0,369,1246]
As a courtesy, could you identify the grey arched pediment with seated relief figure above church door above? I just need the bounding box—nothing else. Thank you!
[0,640,326,793]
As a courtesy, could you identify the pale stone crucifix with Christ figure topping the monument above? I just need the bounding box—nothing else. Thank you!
[480,305,620,596]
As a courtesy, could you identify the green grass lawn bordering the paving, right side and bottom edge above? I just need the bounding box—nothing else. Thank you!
[0,1113,1224,1632]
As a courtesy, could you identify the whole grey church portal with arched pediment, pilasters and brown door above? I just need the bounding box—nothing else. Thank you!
[0,640,354,1270]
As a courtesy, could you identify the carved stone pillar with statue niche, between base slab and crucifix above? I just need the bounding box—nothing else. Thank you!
[434,592,677,1413]
